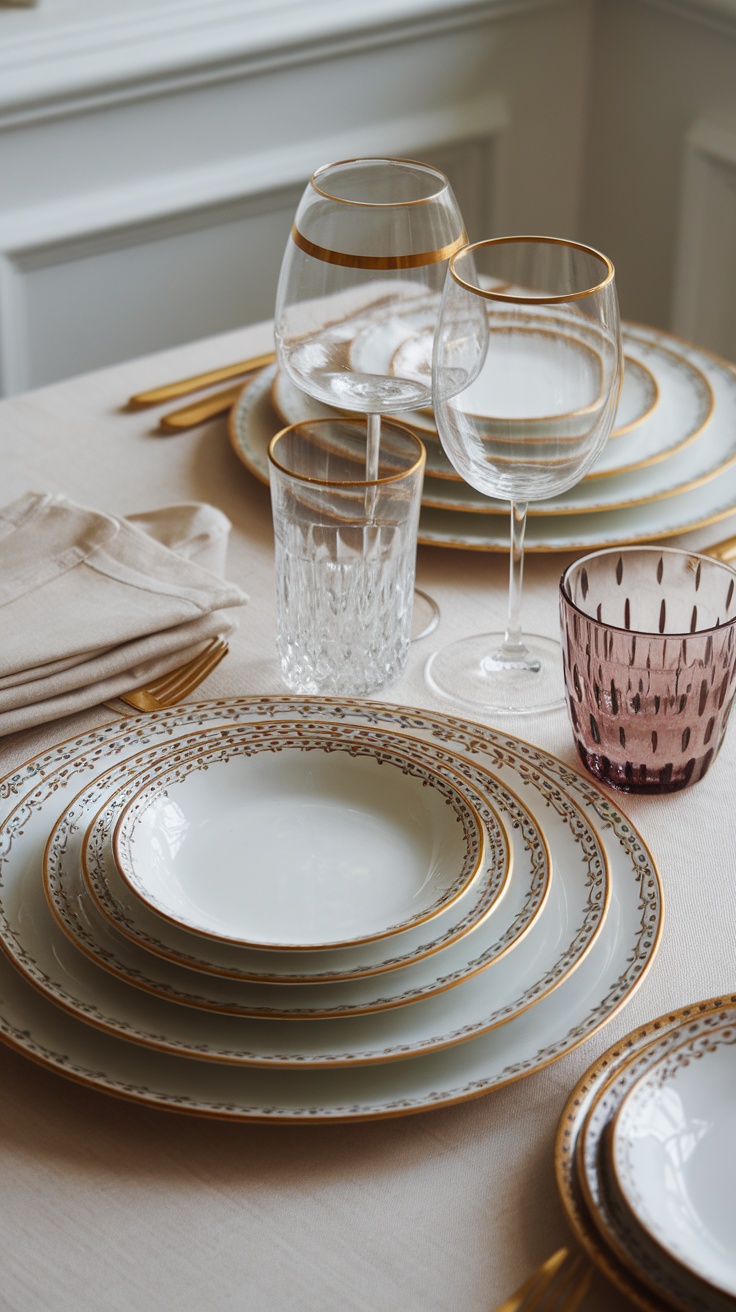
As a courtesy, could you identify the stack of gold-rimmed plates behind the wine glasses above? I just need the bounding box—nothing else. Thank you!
[230,324,736,551]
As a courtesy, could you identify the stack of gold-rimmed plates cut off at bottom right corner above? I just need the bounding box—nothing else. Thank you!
[556,996,736,1312]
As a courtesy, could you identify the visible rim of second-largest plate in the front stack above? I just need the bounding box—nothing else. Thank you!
[18,718,610,1069]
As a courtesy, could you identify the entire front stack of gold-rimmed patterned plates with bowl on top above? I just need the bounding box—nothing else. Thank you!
[0,697,661,1120]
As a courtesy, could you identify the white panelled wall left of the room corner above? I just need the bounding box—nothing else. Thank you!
[0,0,590,394]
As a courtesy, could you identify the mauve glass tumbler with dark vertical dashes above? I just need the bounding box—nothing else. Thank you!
[560,547,736,792]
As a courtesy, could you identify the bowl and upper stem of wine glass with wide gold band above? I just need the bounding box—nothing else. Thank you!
[274,159,467,479]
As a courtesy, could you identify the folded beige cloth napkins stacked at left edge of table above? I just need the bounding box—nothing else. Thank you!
[0,492,248,735]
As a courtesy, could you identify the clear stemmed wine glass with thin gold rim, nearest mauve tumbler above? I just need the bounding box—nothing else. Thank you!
[426,236,622,712]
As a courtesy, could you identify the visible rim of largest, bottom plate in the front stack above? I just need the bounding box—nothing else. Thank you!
[0,697,663,1122]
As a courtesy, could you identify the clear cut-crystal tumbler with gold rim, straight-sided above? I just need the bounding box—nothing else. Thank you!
[269,419,425,697]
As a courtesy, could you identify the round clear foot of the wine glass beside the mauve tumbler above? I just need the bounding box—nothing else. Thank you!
[425,634,565,715]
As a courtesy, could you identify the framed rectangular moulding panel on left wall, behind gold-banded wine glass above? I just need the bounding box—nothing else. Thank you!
[0,94,506,394]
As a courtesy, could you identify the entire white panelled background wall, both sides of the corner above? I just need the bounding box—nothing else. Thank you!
[0,0,736,394]
